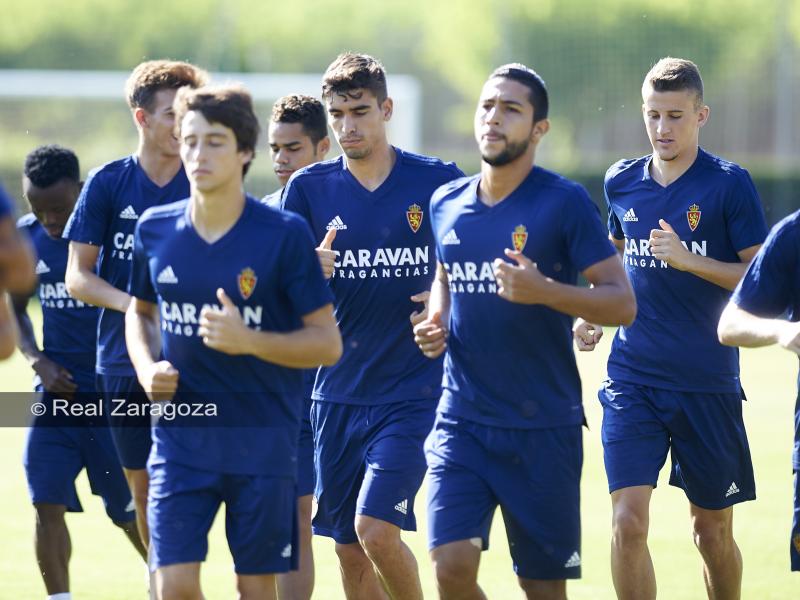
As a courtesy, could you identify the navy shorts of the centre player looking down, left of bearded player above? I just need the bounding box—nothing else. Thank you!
[311,400,436,544]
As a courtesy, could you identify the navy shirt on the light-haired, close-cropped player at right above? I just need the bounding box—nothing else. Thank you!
[605,149,767,393]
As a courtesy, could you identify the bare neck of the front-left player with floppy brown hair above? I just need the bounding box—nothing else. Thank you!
[190,180,246,244]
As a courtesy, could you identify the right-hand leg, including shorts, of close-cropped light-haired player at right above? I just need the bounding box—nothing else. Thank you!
[661,392,755,598]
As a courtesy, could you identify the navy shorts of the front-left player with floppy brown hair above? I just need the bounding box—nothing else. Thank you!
[147,462,298,575]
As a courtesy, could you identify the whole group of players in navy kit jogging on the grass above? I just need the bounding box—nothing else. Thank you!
[0,53,800,600]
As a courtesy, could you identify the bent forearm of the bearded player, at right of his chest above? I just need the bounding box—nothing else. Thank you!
[543,280,636,325]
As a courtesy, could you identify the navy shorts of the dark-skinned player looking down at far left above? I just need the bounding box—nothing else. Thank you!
[23,393,136,523]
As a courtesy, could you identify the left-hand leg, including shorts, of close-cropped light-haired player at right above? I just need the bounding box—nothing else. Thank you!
[598,381,670,599]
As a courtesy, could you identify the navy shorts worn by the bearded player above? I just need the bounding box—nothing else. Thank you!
[425,414,583,580]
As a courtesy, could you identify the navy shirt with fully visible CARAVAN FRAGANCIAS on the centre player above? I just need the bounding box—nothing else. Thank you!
[283,148,463,405]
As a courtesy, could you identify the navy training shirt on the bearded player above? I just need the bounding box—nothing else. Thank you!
[431,167,615,429]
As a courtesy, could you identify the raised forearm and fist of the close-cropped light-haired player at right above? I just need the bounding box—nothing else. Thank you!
[650,219,761,291]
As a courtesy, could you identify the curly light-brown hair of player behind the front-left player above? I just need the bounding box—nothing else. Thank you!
[125,60,208,112]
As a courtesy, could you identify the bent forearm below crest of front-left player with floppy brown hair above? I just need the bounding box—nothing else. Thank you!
[242,325,342,369]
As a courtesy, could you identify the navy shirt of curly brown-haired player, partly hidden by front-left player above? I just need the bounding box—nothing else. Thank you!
[64,155,189,376]
